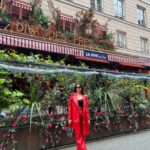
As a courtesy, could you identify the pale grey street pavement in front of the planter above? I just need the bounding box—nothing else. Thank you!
[59,130,150,150]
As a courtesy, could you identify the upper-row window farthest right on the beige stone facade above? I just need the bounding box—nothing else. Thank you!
[137,6,145,27]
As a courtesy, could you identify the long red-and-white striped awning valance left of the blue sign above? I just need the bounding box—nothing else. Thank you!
[0,33,83,56]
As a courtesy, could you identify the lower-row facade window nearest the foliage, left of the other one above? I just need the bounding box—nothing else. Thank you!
[117,32,126,48]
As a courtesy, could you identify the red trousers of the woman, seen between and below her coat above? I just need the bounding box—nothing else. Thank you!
[75,109,87,150]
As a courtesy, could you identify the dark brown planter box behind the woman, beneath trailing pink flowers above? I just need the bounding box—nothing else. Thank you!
[0,118,150,150]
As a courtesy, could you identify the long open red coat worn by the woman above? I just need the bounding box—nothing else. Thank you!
[68,93,90,135]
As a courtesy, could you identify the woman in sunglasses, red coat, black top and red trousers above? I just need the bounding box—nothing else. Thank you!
[68,83,90,150]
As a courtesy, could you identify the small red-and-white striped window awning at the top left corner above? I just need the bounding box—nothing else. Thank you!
[11,0,32,11]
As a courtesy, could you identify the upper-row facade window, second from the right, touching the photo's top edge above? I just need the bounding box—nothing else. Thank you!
[114,0,124,19]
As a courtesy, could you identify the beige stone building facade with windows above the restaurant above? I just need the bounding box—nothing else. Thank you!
[42,0,150,58]
